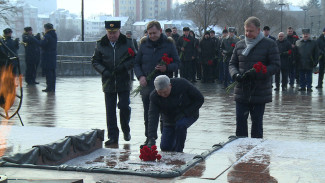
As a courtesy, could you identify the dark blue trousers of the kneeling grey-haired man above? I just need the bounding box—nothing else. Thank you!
[160,117,197,152]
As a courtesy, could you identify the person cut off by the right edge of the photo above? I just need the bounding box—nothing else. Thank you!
[316,27,325,88]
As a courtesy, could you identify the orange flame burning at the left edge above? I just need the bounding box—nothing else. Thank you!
[0,65,22,118]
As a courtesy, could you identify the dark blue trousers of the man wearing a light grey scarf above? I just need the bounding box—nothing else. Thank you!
[236,102,265,138]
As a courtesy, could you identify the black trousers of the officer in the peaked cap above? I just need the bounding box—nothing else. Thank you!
[105,91,131,139]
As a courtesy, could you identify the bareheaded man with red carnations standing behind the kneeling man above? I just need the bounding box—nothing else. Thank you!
[134,21,180,148]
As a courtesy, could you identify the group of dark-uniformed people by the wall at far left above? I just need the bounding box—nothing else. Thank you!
[0,23,57,92]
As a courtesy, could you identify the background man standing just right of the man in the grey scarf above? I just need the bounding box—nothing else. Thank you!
[274,32,292,91]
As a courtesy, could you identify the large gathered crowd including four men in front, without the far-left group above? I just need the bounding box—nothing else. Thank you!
[92,17,325,152]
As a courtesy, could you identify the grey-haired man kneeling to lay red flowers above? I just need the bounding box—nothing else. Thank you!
[148,75,204,152]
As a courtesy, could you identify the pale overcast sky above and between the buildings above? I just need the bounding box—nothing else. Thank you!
[57,0,308,17]
